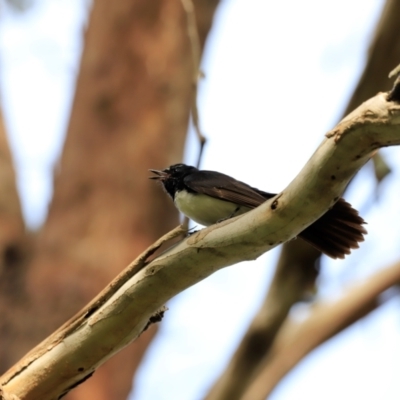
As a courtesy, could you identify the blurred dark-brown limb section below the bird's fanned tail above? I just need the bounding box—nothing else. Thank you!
[205,240,320,400]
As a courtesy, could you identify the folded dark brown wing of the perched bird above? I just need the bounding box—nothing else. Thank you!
[184,171,275,208]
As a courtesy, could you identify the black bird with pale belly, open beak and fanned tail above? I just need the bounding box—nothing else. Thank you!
[150,164,367,258]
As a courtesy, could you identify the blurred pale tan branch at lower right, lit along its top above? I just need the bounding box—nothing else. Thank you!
[241,263,400,400]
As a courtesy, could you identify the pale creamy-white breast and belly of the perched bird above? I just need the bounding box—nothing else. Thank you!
[174,191,249,226]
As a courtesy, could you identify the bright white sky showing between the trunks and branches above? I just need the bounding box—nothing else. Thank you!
[0,0,400,400]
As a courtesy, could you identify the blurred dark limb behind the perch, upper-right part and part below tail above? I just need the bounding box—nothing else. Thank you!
[206,0,400,400]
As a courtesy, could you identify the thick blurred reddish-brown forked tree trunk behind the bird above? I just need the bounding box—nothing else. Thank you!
[0,0,218,400]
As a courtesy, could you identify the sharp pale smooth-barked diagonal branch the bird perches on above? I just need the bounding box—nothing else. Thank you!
[0,93,400,400]
